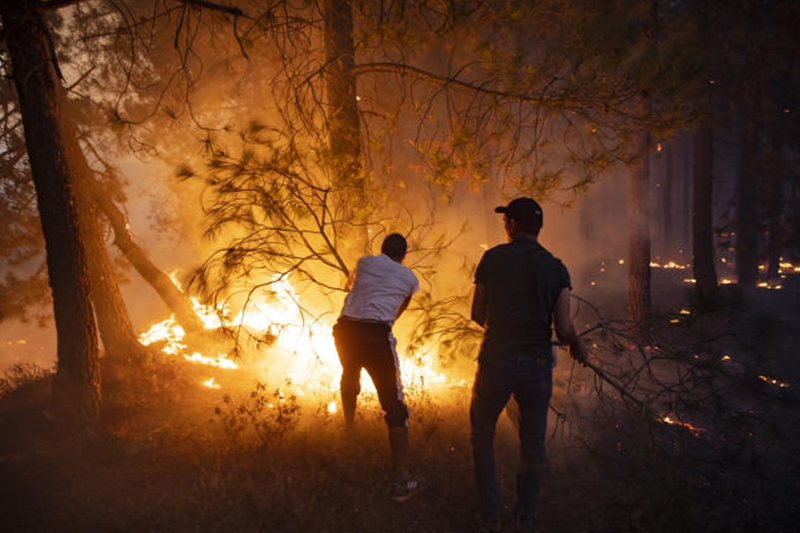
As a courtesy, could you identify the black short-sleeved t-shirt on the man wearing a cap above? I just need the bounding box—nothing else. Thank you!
[475,237,572,356]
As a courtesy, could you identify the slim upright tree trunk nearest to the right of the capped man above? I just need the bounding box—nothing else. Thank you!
[628,125,651,324]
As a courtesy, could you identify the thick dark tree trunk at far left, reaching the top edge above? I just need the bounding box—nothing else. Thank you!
[0,0,100,424]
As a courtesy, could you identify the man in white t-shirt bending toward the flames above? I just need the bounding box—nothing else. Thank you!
[333,233,419,502]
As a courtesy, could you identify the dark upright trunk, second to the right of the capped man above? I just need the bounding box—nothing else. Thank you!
[692,103,717,303]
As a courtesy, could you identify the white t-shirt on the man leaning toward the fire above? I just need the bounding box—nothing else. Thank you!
[342,254,419,325]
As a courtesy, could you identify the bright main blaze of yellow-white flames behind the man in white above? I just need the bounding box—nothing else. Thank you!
[139,278,456,396]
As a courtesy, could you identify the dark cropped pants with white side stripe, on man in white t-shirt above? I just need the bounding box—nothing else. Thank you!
[333,318,408,427]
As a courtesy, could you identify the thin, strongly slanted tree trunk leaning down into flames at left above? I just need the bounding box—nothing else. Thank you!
[87,174,205,333]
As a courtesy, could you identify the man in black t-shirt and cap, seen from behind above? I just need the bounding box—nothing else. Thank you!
[470,198,587,530]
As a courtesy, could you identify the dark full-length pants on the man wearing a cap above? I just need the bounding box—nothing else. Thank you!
[469,354,553,517]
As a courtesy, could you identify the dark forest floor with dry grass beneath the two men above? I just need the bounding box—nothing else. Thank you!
[0,272,800,533]
